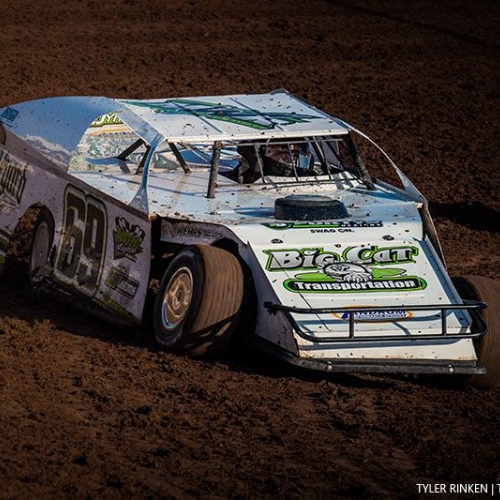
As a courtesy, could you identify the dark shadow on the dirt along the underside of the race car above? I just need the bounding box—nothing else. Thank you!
[0,282,478,389]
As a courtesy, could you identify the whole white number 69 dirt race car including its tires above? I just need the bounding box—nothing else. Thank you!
[0,90,500,388]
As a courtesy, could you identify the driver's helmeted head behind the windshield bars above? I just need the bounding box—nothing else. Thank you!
[262,142,311,177]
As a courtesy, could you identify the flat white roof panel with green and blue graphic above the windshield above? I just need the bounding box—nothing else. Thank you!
[120,91,347,141]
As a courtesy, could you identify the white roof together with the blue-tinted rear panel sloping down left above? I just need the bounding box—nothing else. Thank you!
[0,90,351,171]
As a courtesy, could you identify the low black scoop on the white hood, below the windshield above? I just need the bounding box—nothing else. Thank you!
[274,194,349,221]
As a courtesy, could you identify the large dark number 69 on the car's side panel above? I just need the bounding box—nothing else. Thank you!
[55,186,106,295]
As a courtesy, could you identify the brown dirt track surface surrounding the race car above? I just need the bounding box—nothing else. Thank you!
[0,0,500,499]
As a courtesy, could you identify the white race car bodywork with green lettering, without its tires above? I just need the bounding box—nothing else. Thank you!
[0,91,484,374]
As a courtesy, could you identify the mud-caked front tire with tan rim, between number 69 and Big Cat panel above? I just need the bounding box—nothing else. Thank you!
[153,245,243,357]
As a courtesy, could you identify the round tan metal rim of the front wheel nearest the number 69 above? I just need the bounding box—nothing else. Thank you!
[161,267,193,331]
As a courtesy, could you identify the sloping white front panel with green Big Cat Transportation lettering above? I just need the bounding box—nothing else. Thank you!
[242,224,467,344]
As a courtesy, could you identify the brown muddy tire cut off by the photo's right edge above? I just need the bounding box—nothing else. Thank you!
[453,276,500,390]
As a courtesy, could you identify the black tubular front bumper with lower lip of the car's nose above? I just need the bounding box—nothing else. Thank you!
[259,300,487,375]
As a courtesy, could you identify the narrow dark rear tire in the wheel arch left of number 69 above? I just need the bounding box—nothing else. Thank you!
[28,208,54,290]
